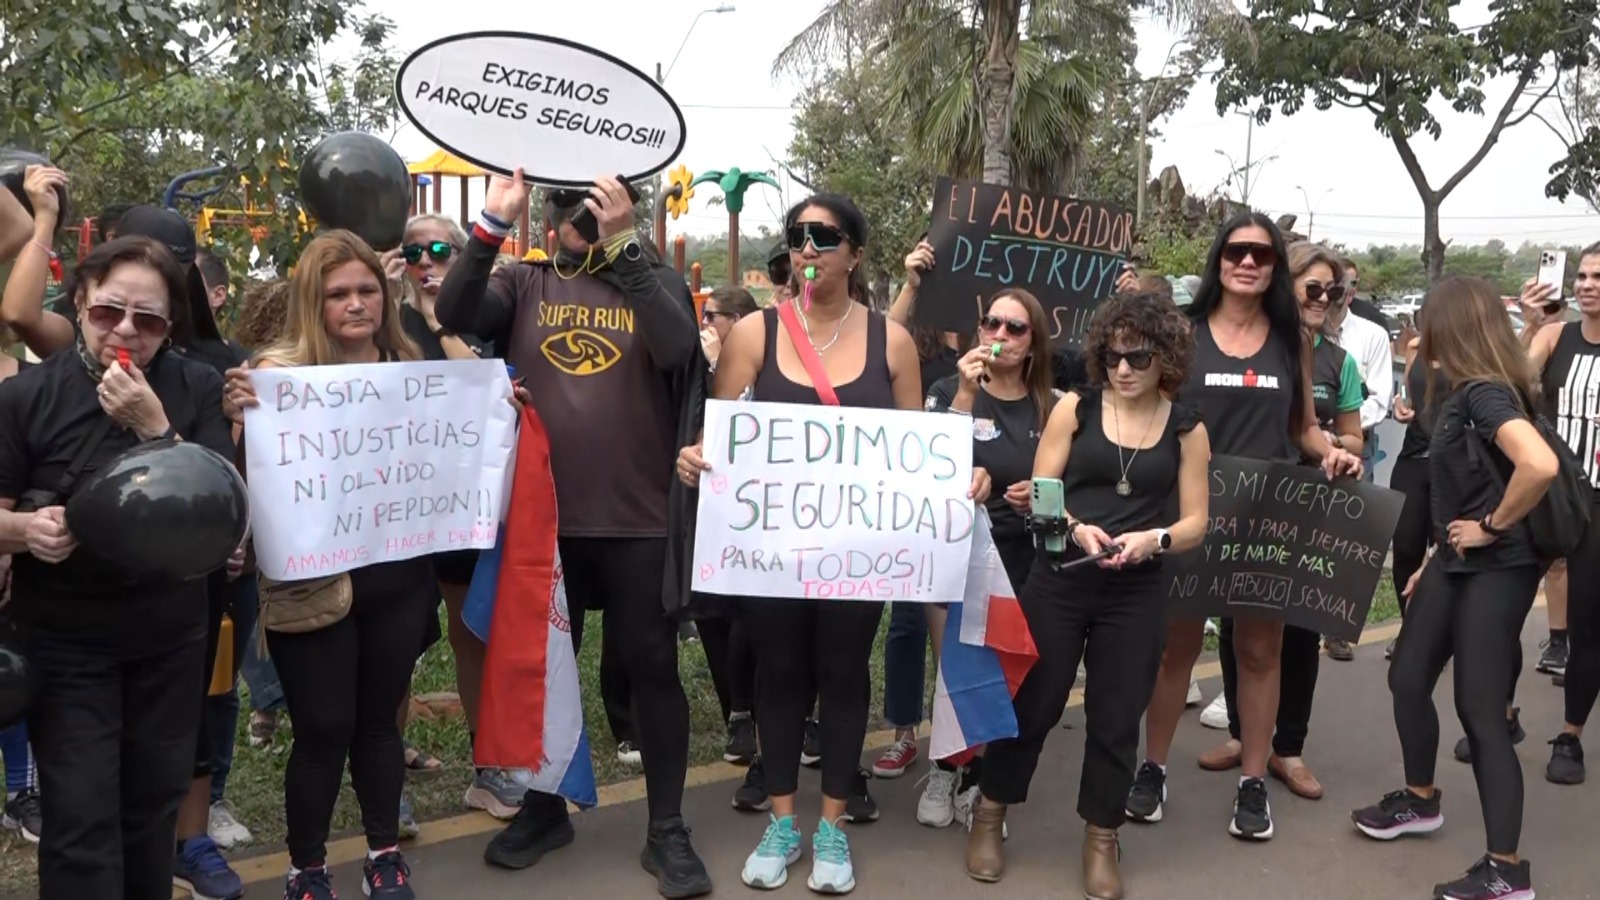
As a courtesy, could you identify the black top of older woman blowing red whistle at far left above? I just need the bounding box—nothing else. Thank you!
[0,344,234,650]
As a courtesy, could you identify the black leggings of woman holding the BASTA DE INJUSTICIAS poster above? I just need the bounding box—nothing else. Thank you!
[267,557,438,868]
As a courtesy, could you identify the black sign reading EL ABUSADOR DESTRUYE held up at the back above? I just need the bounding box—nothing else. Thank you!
[917,178,1133,343]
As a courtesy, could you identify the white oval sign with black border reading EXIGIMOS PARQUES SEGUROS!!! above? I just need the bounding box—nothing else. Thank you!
[395,32,685,187]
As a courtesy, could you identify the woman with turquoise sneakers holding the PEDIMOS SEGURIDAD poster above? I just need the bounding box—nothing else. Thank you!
[678,194,989,894]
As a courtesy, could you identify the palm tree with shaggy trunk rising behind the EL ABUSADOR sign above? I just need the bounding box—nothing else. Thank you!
[774,0,1248,192]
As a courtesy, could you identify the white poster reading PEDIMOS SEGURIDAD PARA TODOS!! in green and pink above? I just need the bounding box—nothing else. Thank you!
[694,400,974,602]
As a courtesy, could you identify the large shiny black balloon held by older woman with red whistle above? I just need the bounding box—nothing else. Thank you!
[67,440,250,581]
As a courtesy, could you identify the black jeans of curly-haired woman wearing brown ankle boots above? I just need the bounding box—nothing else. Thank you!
[979,560,1166,828]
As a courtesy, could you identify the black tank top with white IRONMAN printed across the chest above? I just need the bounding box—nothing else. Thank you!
[1177,319,1299,461]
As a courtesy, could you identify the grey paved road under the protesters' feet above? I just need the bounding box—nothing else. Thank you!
[228,610,1600,900]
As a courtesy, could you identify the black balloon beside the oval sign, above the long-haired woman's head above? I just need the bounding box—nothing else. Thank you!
[299,131,411,251]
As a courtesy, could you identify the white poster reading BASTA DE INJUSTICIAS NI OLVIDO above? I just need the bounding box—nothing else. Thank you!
[245,359,517,581]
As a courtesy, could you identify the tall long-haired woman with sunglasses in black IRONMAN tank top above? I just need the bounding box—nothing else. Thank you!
[1128,213,1362,841]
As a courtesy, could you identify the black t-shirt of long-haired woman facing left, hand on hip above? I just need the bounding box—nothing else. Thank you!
[1429,381,1539,572]
